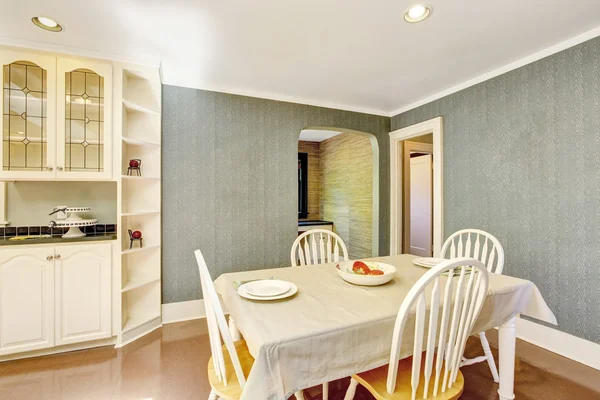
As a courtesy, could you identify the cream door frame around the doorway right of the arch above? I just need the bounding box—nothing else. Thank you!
[390,116,444,257]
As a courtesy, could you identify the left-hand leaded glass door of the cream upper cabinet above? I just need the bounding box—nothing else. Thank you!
[0,52,56,178]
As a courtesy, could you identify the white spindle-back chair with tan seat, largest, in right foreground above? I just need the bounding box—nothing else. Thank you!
[344,257,489,400]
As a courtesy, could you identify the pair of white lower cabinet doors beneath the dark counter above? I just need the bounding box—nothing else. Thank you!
[0,243,112,356]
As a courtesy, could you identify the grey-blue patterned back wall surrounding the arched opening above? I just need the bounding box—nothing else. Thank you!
[162,86,390,303]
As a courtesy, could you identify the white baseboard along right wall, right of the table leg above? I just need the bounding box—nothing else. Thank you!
[517,318,600,370]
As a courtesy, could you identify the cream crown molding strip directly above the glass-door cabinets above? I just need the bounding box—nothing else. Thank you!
[0,36,160,68]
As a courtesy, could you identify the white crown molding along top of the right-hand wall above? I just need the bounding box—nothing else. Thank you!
[388,27,600,117]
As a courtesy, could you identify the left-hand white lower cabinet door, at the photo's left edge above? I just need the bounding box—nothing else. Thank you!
[0,247,54,355]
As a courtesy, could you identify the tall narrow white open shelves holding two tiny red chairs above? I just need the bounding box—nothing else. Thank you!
[115,65,162,345]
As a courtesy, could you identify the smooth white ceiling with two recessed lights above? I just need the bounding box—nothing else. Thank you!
[0,0,600,115]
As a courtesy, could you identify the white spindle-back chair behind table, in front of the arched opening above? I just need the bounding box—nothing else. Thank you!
[290,229,348,400]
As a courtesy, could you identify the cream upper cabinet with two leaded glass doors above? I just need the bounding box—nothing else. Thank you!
[0,50,113,180]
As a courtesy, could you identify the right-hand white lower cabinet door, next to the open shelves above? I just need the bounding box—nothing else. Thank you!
[55,243,112,346]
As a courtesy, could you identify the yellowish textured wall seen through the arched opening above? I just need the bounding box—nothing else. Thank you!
[320,133,373,259]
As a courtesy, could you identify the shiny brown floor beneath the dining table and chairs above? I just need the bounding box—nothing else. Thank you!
[0,320,600,400]
